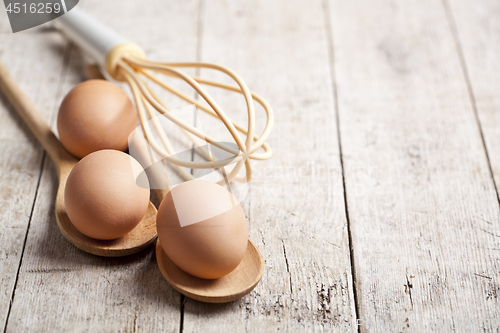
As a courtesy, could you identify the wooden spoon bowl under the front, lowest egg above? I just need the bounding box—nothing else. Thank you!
[156,239,265,303]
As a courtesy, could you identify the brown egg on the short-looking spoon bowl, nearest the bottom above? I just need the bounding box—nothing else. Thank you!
[156,180,248,279]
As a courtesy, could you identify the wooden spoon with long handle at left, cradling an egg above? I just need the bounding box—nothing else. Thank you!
[0,64,156,257]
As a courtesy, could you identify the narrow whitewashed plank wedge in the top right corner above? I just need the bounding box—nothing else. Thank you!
[446,0,500,204]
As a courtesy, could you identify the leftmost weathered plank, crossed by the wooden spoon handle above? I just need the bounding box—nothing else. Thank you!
[0,34,69,328]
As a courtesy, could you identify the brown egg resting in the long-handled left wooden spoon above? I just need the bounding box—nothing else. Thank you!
[64,150,149,239]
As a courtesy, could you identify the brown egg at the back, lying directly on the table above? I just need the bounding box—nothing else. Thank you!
[57,80,136,158]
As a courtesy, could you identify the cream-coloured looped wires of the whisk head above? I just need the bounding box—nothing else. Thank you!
[114,54,274,182]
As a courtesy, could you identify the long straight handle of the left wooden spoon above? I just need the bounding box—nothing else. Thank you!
[0,63,64,167]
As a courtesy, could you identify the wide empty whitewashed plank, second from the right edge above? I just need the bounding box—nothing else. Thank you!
[329,0,500,332]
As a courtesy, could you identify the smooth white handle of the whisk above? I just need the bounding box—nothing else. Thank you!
[55,7,130,66]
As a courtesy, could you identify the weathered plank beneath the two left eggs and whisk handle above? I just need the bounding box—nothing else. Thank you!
[5,0,198,332]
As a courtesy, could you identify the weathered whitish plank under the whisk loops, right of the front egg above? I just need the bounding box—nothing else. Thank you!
[183,1,355,332]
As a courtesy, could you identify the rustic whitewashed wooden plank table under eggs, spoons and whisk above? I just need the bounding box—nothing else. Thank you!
[0,0,500,332]
